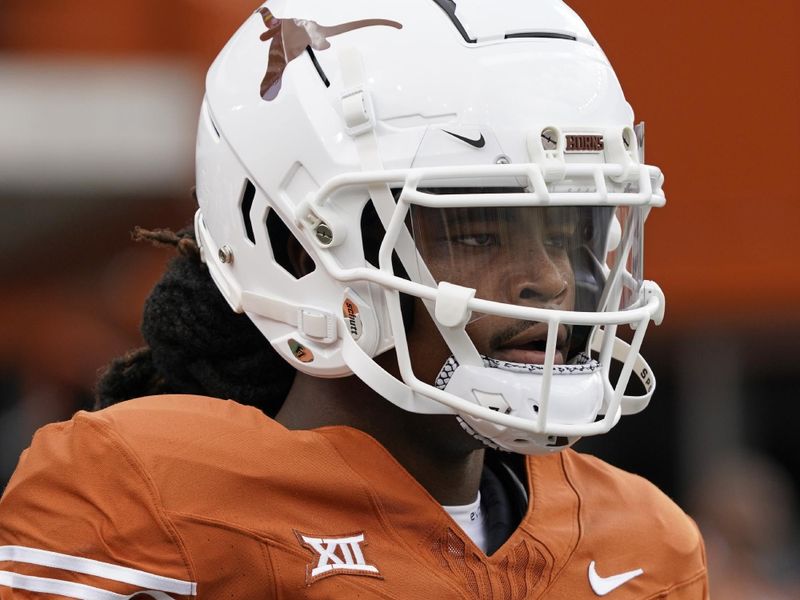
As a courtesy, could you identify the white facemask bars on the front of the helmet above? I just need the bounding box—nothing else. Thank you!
[297,163,664,436]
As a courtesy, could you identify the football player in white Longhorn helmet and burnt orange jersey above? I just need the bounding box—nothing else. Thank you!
[0,0,708,600]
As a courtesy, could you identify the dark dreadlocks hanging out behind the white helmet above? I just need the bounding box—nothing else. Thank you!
[95,227,295,415]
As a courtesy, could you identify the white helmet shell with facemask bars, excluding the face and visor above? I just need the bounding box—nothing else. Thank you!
[196,0,664,453]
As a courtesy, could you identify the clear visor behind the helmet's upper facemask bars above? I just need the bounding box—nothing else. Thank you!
[411,193,643,320]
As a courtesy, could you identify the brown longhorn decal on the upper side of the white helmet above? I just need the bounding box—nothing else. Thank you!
[257,6,403,101]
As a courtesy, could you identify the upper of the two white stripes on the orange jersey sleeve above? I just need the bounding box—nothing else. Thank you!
[0,546,197,598]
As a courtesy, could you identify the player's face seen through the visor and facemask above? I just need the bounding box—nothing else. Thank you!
[409,207,580,378]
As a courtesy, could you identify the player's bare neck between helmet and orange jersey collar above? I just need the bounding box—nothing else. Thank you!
[276,373,484,505]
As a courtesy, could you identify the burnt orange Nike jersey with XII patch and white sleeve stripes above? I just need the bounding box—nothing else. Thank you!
[0,396,707,600]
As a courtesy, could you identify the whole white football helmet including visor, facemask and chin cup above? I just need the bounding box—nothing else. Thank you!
[195,0,665,454]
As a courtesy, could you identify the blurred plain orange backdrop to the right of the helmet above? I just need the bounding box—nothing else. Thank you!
[570,0,800,327]
